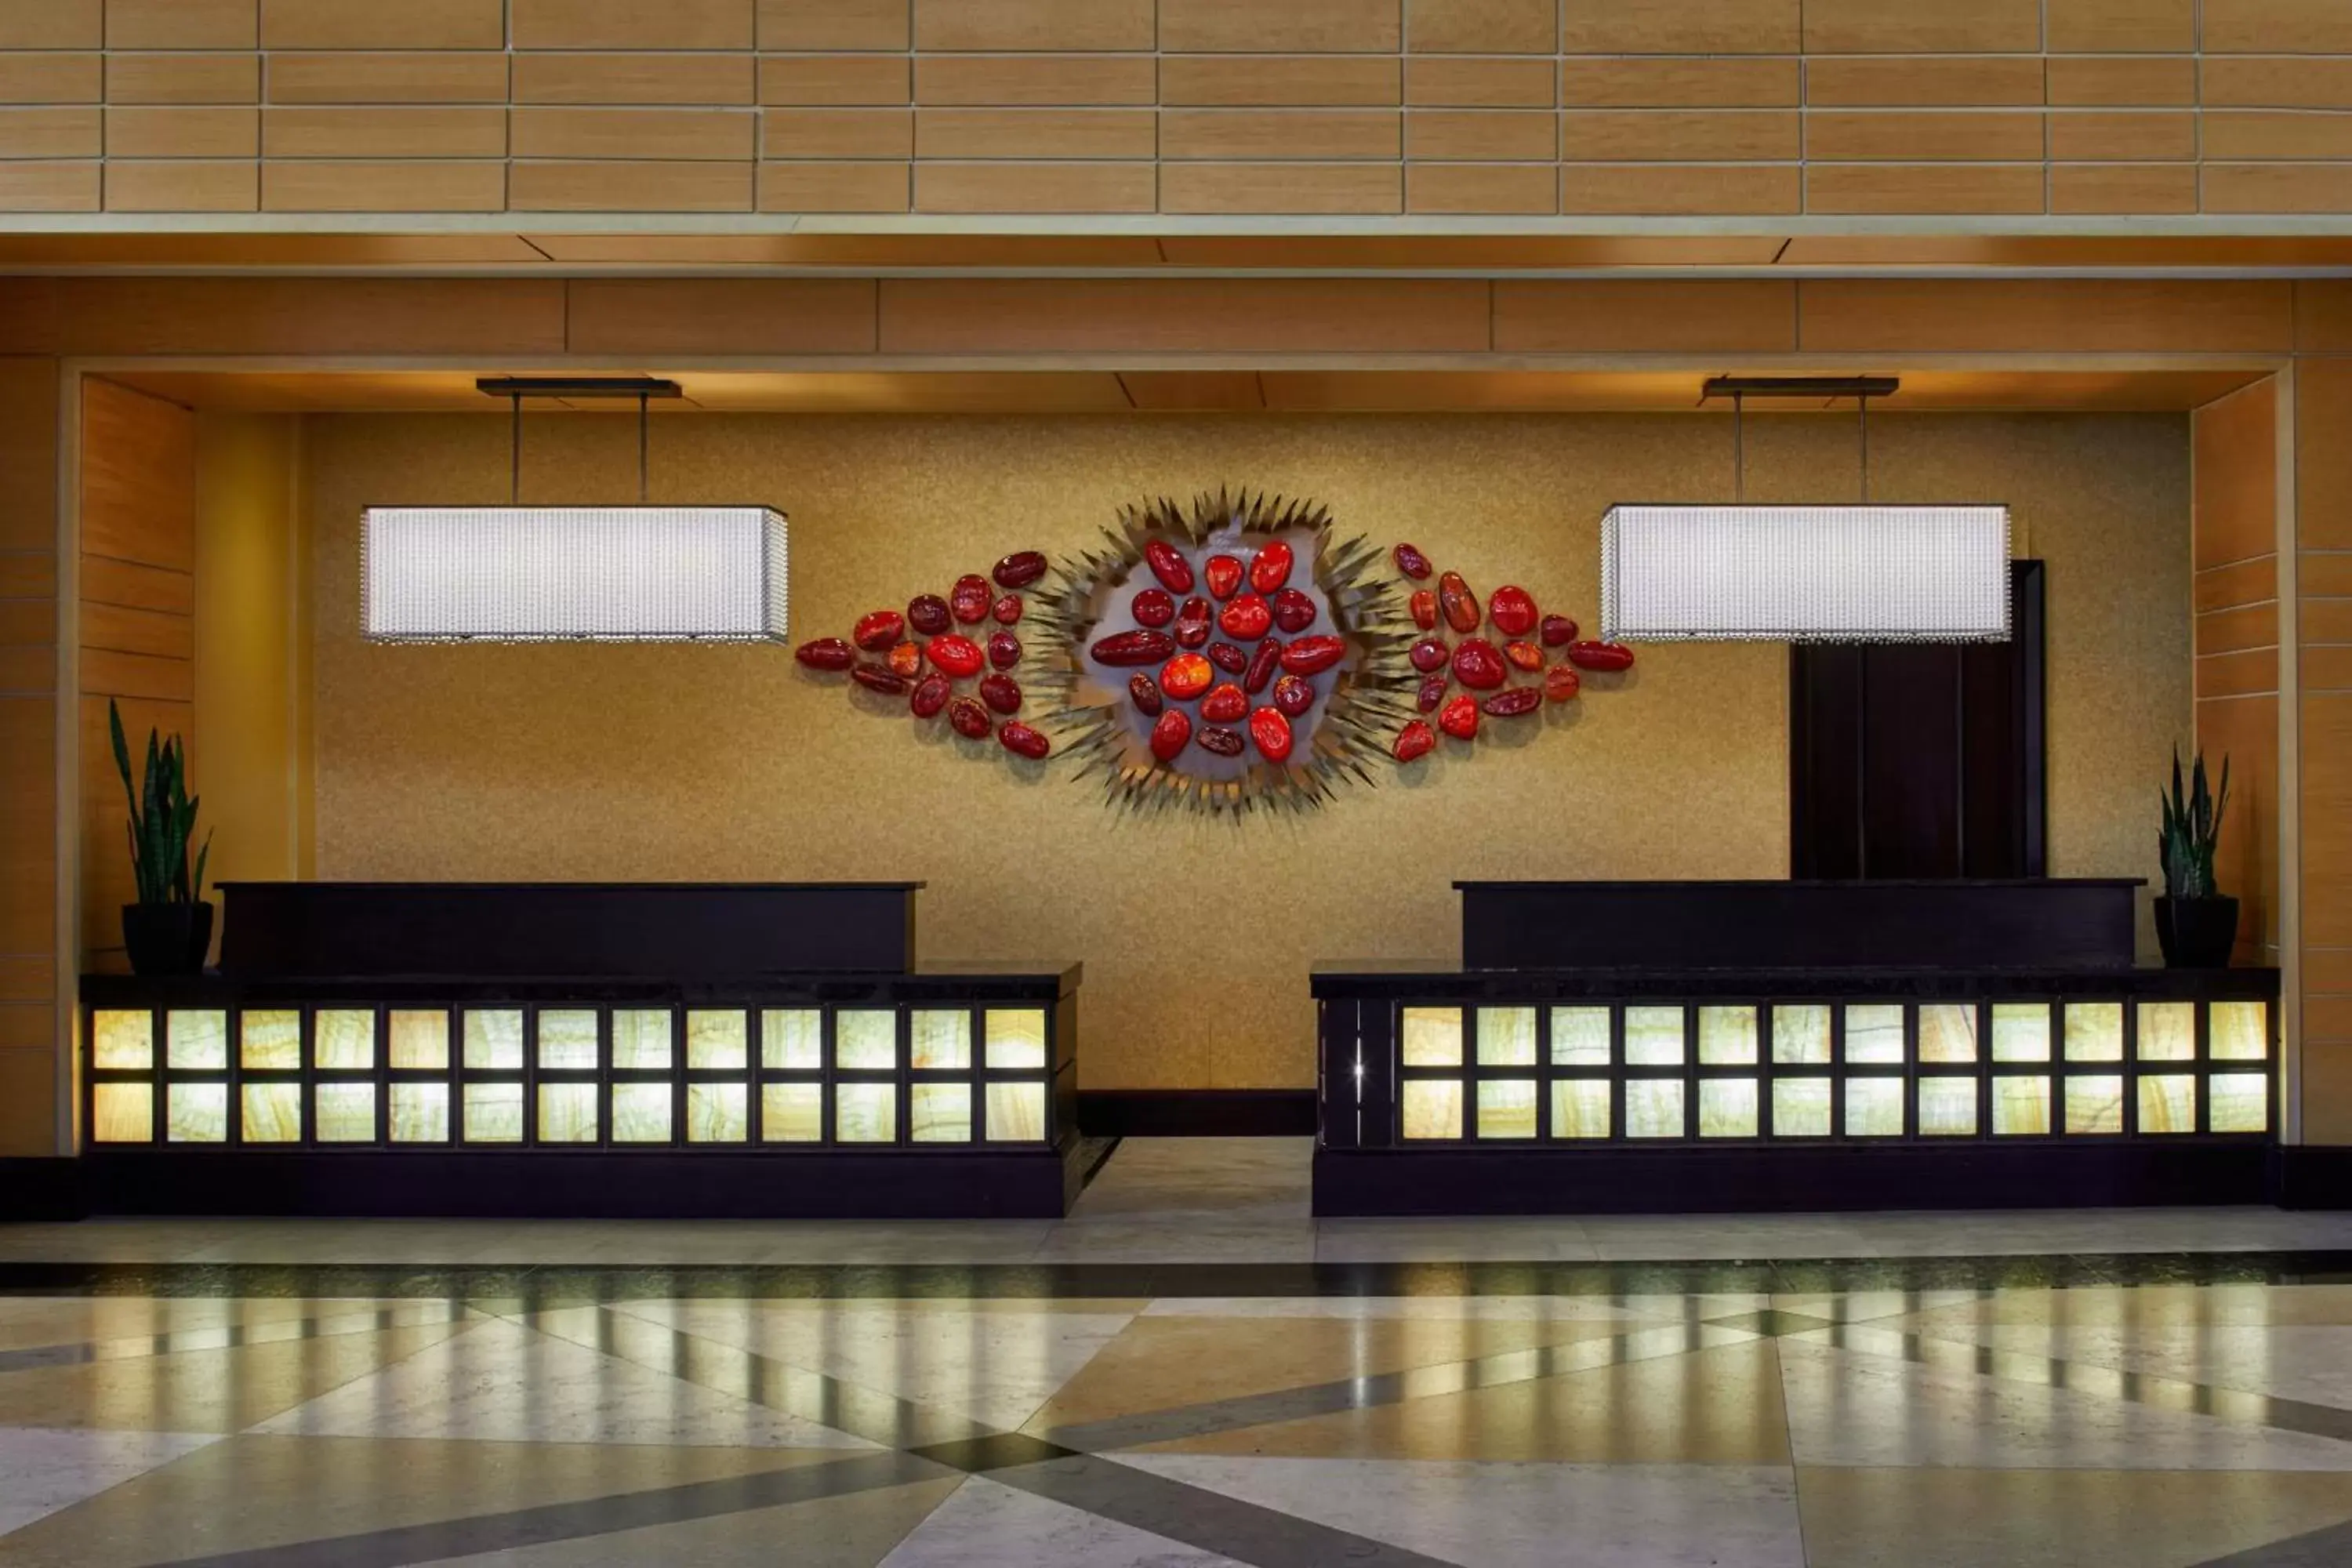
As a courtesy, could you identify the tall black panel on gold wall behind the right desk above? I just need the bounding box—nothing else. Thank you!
[1790,562,2046,879]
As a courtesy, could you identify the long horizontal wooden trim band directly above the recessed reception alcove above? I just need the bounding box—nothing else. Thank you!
[0,275,2333,365]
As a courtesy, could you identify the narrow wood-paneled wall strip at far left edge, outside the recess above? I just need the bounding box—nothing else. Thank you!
[0,358,59,1159]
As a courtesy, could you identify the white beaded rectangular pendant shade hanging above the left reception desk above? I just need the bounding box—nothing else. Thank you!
[360,506,786,642]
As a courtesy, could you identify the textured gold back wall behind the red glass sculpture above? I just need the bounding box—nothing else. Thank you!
[306,416,2190,1088]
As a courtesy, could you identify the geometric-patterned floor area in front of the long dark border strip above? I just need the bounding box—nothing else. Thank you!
[13,1258,2352,1568]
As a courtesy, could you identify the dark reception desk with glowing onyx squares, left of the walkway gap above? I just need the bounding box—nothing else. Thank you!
[80,884,1084,1218]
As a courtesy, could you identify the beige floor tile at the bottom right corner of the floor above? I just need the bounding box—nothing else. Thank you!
[1797,1469,2352,1568]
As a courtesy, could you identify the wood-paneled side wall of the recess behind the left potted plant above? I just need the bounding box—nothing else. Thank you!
[80,376,195,968]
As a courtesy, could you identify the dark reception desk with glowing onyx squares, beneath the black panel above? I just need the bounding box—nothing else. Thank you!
[1312,881,2279,1215]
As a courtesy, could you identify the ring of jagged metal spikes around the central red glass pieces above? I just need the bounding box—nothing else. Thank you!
[1030,489,1414,818]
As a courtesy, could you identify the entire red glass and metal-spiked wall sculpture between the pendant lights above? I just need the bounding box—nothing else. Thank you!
[795,503,1632,813]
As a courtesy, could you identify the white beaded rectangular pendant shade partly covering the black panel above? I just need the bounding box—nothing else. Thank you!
[1602,506,2009,642]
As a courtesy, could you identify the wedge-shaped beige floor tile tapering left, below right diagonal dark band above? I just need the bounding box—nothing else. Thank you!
[1124,1340,1788,1465]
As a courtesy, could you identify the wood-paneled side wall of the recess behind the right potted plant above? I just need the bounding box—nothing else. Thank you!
[2192,381,2279,964]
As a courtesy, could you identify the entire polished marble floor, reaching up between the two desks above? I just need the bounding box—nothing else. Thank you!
[0,1142,2352,1568]
